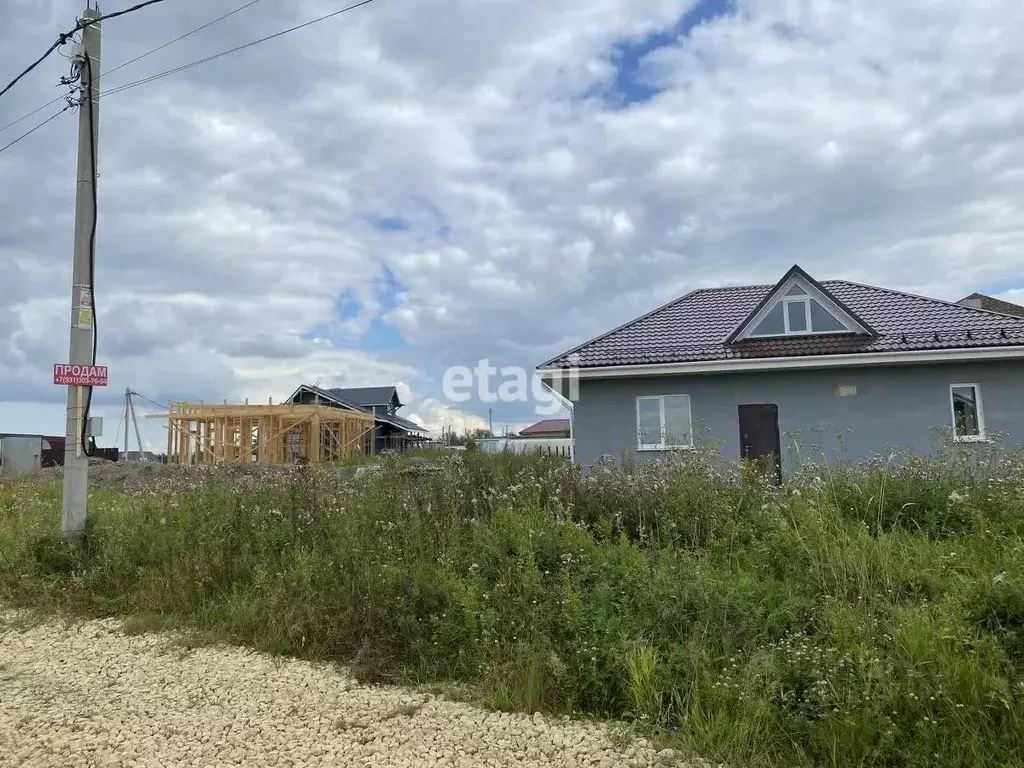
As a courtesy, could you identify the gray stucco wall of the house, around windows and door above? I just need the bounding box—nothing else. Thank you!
[573,361,1024,471]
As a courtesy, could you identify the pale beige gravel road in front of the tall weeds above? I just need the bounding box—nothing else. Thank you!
[0,613,692,768]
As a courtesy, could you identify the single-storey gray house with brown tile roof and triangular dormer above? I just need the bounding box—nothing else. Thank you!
[539,266,1024,479]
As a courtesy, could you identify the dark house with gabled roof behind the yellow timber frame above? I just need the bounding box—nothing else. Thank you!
[286,384,427,453]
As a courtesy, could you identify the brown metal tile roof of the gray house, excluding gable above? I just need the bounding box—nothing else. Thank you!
[542,281,1024,368]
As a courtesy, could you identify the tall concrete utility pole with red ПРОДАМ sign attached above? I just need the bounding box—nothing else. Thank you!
[60,8,101,541]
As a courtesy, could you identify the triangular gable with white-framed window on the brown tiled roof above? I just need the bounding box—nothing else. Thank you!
[724,265,877,344]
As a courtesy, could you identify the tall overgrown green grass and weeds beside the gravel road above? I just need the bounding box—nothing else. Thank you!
[0,453,1024,768]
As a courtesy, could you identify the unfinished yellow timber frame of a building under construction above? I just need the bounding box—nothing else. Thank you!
[148,402,375,464]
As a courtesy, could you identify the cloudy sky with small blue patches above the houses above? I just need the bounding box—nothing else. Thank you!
[0,0,1024,443]
